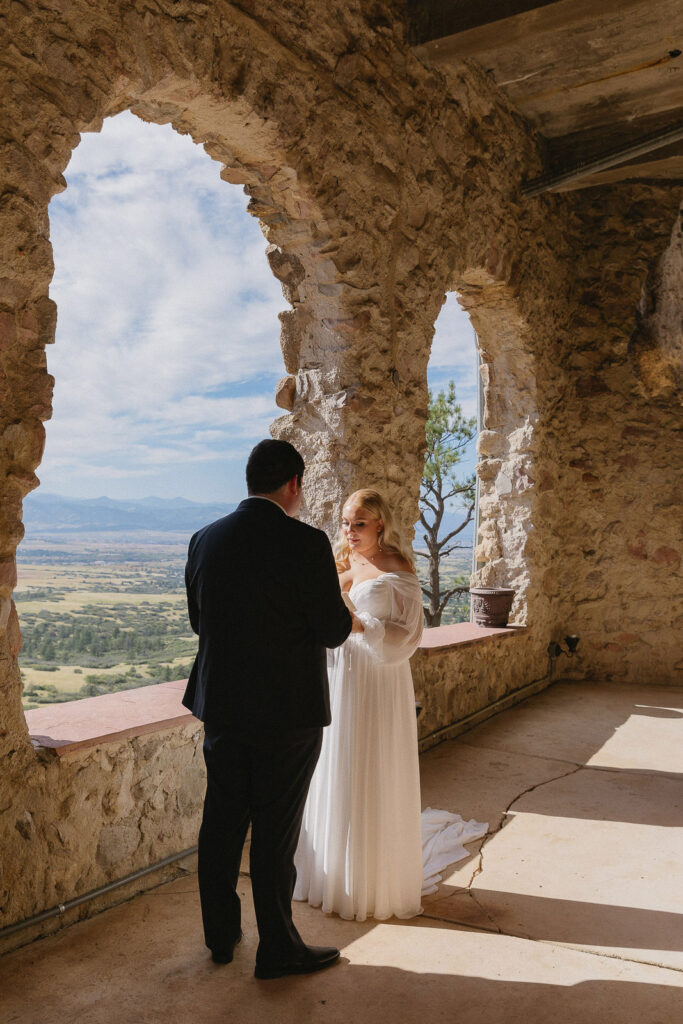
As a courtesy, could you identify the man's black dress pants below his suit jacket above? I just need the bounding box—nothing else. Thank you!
[199,723,323,965]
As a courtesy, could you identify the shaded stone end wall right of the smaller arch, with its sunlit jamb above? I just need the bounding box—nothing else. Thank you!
[458,192,683,684]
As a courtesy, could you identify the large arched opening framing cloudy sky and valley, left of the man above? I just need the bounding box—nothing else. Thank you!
[15,113,283,710]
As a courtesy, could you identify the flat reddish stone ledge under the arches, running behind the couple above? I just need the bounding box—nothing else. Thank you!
[26,623,525,758]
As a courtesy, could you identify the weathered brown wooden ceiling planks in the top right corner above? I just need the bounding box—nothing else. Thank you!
[418,0,683,145]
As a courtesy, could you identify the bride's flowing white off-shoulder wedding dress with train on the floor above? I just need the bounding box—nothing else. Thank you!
[294,572,487,921]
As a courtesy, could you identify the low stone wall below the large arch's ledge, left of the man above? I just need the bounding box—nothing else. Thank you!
[0,720,205,952]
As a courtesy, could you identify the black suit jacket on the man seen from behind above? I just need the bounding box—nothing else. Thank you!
[182,498,351,732]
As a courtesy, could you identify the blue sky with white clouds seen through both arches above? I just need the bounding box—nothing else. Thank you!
[38,113,476,502]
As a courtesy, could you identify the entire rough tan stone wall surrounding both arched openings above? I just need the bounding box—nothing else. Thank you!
[0,0,680,942]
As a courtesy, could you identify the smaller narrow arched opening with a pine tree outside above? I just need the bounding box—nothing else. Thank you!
[415,292,479,626]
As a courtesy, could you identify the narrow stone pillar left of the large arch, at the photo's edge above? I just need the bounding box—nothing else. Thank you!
[0,134,61,756]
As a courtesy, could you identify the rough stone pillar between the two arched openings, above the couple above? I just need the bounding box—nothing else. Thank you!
[232,166,446,538]
